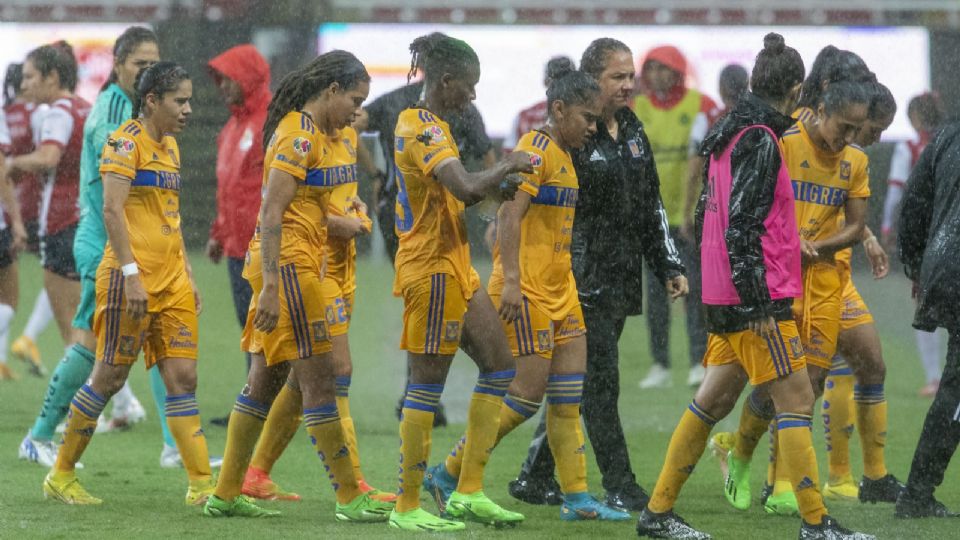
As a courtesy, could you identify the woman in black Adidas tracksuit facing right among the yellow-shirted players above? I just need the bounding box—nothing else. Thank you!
[510,38,687,510]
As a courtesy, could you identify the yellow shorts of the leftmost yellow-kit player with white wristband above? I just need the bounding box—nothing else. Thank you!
[93,265,198,369]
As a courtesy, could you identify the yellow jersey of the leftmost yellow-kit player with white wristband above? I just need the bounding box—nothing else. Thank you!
[100,120,185,294]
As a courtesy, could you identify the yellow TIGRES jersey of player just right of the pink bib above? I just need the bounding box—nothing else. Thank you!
[782,122,870,241]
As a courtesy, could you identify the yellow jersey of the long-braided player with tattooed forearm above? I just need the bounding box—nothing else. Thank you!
[244,112,332,278]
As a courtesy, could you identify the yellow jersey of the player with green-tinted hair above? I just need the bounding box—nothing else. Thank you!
[393,109,479,298]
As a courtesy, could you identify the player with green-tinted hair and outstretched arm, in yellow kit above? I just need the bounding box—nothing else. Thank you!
[390,33,533,531]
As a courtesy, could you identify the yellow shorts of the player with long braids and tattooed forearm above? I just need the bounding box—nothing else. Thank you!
[240,263,333,366]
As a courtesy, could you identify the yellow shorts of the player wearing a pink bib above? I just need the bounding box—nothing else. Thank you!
[703,320,806,386]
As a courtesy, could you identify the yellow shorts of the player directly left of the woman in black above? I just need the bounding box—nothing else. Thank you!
[490,295,587,360]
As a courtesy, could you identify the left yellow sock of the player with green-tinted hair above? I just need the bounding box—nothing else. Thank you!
[396,384,443,512]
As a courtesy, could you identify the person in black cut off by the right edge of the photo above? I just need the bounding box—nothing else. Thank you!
[895,124,960,518]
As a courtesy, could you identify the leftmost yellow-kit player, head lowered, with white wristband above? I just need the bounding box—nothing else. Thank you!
[43,62,213,504]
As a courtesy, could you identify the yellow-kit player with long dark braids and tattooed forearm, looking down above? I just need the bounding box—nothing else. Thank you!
[204,51,391,522]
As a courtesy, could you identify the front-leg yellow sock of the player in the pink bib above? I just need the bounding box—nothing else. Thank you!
[776,413,827,525]
